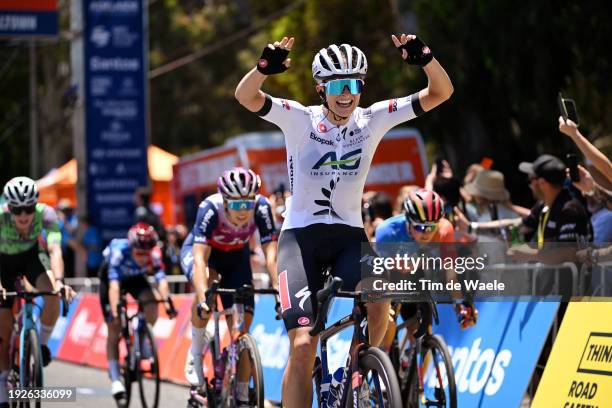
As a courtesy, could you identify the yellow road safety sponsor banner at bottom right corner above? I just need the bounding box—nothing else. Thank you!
[532,302,612,408]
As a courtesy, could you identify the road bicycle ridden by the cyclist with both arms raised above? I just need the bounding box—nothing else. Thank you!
[310,277,402,408]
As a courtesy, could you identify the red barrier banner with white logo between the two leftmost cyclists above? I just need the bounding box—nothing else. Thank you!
[57,295,105,364]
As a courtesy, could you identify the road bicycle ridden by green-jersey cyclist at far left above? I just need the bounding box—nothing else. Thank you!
[6,279,68,408]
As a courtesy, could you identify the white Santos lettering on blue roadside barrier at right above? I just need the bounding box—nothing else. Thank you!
[426,337,512,395]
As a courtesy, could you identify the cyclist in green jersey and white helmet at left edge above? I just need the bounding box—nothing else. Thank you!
[0,177,73,404]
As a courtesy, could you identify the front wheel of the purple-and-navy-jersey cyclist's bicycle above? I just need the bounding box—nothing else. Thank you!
[236,333,264,408]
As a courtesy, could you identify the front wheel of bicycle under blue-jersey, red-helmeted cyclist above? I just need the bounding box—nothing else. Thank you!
[136,323,160,408]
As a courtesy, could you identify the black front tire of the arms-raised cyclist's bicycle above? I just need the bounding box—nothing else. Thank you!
[346,347,402,408]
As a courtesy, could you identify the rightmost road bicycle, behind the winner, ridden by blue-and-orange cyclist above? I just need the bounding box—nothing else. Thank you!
[389,300,457,408]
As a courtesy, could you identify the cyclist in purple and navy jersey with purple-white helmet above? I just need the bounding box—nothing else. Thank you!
[181,167,278,403]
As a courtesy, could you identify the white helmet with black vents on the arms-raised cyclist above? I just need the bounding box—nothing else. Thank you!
[312,44,368,83]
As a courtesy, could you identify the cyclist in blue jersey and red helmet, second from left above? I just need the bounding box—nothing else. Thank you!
[99,222,170,404]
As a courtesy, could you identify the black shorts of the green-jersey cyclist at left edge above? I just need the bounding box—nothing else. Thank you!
[0,245,49,309]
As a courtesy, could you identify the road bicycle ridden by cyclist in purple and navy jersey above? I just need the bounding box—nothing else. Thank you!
[187,281,278,408]
